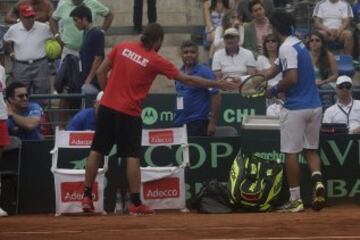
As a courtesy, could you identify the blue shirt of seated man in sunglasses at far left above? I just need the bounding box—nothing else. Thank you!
[7,102,43,140]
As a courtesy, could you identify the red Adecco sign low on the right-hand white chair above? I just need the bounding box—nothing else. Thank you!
[143,178,180,200]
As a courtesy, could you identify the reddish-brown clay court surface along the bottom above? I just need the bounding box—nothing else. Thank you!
[0,205,360,240]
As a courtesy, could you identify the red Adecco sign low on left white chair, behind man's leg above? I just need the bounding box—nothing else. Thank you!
[60,181,99,202]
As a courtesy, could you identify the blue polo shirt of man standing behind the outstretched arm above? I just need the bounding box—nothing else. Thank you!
[174,64,219,126]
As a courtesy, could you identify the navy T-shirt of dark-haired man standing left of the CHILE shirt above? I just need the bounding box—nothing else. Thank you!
[80,27,105,89]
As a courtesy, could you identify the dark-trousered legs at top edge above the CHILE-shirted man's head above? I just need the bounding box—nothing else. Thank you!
[133,0,157,33]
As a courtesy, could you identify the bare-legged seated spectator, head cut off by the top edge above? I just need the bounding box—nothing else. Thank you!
[203,0,229,52]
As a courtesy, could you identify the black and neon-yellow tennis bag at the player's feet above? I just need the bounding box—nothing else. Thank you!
[228,152,283,212]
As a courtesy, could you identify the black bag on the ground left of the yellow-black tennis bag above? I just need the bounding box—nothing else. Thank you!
[192,179,232,213]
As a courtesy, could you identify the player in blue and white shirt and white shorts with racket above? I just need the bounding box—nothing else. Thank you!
[262,11,325,212]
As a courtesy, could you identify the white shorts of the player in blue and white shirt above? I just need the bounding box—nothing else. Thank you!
[279,107,322,153]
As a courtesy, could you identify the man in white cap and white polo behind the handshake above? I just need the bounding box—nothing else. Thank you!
[212,28,256,79]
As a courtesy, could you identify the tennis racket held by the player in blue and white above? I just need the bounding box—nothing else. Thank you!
[239,74,267,98]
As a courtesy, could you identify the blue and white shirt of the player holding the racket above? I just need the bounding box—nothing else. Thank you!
[276,36,321,110]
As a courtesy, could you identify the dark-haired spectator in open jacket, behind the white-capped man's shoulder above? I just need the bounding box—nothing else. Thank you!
[243,0,271,58]
